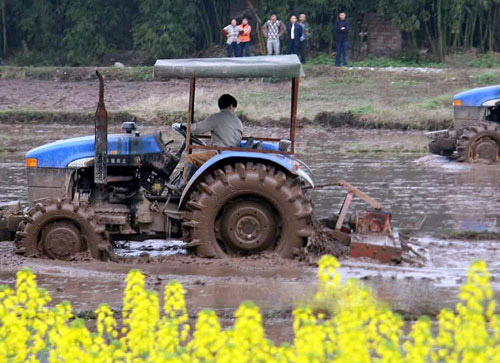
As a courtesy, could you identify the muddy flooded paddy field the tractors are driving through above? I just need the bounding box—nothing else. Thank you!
[0,124,500,341]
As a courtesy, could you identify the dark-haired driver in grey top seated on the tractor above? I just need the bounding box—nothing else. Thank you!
[183,94,243,185]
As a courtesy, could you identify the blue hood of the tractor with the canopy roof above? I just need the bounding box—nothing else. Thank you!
[26,133,162,168]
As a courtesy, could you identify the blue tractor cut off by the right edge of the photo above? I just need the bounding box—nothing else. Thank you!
[427,86,500,162]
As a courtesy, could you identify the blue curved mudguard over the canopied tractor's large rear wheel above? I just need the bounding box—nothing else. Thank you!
[179,151,314,210]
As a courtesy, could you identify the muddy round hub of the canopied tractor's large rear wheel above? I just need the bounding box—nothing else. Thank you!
[221,201,277,252]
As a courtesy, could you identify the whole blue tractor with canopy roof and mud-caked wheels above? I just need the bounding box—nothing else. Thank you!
[15,55,313,260]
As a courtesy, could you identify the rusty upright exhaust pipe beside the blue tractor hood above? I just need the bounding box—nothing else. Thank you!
[94,70,108,186]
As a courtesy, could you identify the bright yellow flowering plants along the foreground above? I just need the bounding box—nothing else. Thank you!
[0,256,500,363]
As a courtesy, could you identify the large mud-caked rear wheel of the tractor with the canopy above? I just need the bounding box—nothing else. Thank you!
[183,162,313,258]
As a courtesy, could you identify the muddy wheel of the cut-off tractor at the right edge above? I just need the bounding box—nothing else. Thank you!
[457,122,500,162]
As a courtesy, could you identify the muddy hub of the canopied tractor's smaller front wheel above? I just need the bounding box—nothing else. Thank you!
[41,222,82,260]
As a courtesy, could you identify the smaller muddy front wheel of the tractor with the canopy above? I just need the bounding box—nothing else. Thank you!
[15,200,112,260]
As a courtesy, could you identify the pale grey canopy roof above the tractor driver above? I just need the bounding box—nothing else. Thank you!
[154,54,304,78]
